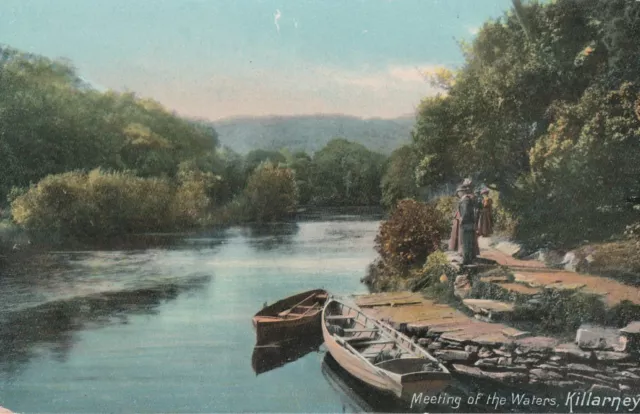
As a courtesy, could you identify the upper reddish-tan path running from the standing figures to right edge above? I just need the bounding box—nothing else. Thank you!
[479,238,640,306]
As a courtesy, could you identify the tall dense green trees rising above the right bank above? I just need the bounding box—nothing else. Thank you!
[414,0,640,245]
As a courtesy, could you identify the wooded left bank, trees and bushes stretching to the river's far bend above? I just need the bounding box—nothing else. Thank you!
[0,46,386,252]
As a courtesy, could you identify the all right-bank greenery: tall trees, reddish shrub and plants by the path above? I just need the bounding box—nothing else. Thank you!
[366,0,640,335]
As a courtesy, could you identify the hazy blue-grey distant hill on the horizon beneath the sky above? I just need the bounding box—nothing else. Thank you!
[211,115,415,154]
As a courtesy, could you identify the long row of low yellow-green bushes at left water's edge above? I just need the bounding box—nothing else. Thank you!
[11,169,218,239]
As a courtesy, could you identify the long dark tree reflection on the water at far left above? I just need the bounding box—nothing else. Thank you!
[0,275,210,377]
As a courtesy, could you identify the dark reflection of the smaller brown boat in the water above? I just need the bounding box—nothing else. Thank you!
[251,335,323,375]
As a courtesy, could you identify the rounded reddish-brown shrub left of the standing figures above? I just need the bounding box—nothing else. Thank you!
[375,200,443,268]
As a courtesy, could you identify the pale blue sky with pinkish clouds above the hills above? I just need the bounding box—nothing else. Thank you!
[0,0,512,121]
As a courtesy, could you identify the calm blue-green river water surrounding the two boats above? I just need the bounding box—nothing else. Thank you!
[0,216,560,413]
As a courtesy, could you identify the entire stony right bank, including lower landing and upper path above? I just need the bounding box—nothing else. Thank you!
[357,238,640,395]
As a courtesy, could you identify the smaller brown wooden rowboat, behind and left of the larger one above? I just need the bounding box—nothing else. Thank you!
[253,289,328,345]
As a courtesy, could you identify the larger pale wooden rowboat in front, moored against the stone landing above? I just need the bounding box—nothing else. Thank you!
[322,298,451,400]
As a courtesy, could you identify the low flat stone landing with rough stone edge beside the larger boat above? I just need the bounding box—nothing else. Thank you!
[356,291,640,395]
